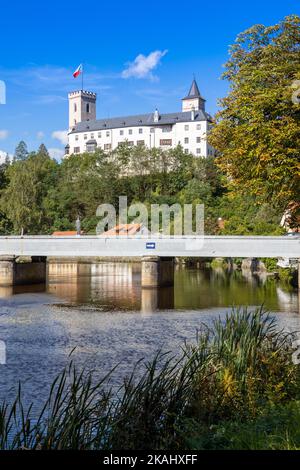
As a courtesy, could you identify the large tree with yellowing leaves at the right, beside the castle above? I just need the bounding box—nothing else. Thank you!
[209,16,300,215]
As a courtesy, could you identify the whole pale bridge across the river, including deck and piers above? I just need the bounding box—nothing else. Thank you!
[0,236,300,287]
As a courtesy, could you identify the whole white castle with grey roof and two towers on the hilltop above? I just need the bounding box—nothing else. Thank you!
[65,80,215,157]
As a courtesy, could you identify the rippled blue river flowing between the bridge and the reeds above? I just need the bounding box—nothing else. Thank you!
[0,262,300,414]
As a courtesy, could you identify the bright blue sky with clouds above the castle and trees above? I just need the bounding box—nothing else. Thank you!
[0,0,300,159]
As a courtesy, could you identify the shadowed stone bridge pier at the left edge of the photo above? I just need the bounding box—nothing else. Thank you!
[0,255,47,287]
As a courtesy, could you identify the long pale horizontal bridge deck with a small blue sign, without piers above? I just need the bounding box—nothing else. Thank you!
[0,236,300,258]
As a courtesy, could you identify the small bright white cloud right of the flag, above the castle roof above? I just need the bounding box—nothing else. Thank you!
[122,50,168,80]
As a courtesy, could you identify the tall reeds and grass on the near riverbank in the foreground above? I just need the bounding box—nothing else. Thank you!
[0,309,300,450]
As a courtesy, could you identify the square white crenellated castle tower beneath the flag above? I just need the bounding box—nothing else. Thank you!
[69,90,97,129]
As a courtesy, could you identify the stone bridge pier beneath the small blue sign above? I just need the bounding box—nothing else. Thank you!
[142,256,174,287]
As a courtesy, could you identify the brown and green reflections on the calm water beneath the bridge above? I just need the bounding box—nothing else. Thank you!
[0,262,300,313]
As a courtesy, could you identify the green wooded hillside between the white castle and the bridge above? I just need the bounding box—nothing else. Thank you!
[0,140,282,235]
